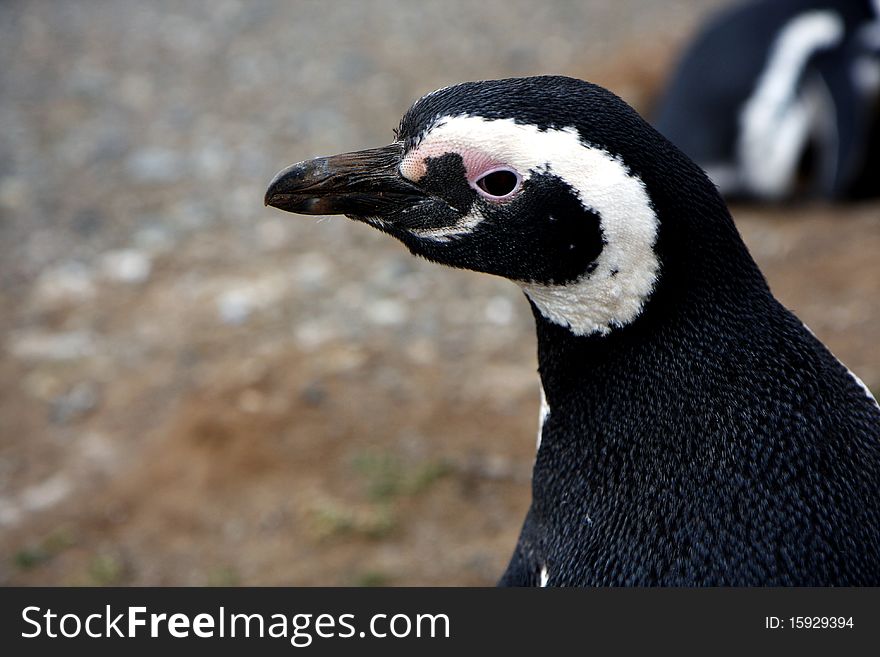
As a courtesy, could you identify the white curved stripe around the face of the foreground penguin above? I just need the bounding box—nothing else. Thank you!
[412,116,660,335]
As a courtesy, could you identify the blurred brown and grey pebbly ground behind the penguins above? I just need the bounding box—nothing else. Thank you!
[0,0,880,585]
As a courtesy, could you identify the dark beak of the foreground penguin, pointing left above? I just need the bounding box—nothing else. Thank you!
[265,143,425,217]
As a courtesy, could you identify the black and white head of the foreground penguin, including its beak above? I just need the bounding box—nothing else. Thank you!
[266,77,717,335]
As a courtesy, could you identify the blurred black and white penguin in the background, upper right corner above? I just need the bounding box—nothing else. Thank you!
[655,0,880,201]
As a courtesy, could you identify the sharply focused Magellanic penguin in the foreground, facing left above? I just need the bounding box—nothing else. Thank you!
[265,77,880,586]
